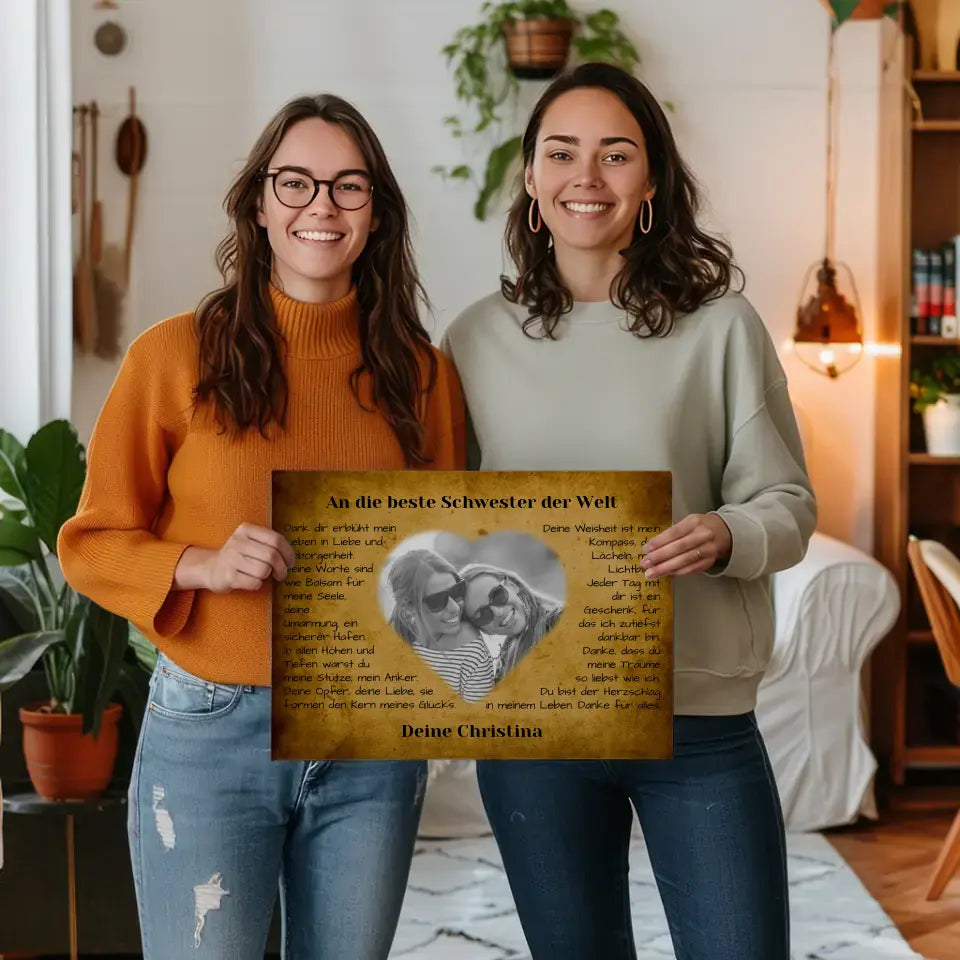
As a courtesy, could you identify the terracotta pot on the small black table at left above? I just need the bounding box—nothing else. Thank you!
[20,703,123,800]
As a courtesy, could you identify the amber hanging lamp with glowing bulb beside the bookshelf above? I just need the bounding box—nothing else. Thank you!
[793,257,863,379]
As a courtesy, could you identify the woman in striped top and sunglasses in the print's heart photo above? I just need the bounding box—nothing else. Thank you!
[387,550,494,702]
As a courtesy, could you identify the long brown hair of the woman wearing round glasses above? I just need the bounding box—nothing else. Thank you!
[194,94,437,464]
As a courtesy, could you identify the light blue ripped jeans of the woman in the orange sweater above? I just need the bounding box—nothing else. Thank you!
[127,655,426,960]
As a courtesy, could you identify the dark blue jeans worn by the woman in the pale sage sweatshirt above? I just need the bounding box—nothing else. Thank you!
[477,713,790,960]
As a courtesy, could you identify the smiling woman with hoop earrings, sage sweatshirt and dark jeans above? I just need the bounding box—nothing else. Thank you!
[444,63,816,960]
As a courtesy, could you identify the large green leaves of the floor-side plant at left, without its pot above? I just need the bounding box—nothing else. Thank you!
[0,420,156,736]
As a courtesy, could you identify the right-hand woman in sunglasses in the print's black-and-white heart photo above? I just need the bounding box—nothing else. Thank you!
[460,563,563,682]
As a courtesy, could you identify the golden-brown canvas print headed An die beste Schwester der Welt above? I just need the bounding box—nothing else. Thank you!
[272,471,673,759]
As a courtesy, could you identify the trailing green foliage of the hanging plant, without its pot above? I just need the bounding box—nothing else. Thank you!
[433,0,640,220]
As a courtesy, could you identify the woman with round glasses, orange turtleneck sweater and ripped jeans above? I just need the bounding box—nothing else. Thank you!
[59,96,464,960]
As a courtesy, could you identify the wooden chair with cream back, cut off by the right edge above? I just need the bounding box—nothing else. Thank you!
[907,537,960,900]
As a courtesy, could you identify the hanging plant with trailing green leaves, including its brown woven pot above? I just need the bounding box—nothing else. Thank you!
[433,0,640,220]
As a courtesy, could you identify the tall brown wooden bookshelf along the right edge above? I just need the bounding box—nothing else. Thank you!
[870,33,960,800]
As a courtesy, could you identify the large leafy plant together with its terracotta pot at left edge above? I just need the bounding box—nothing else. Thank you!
[0,420,156,799]
